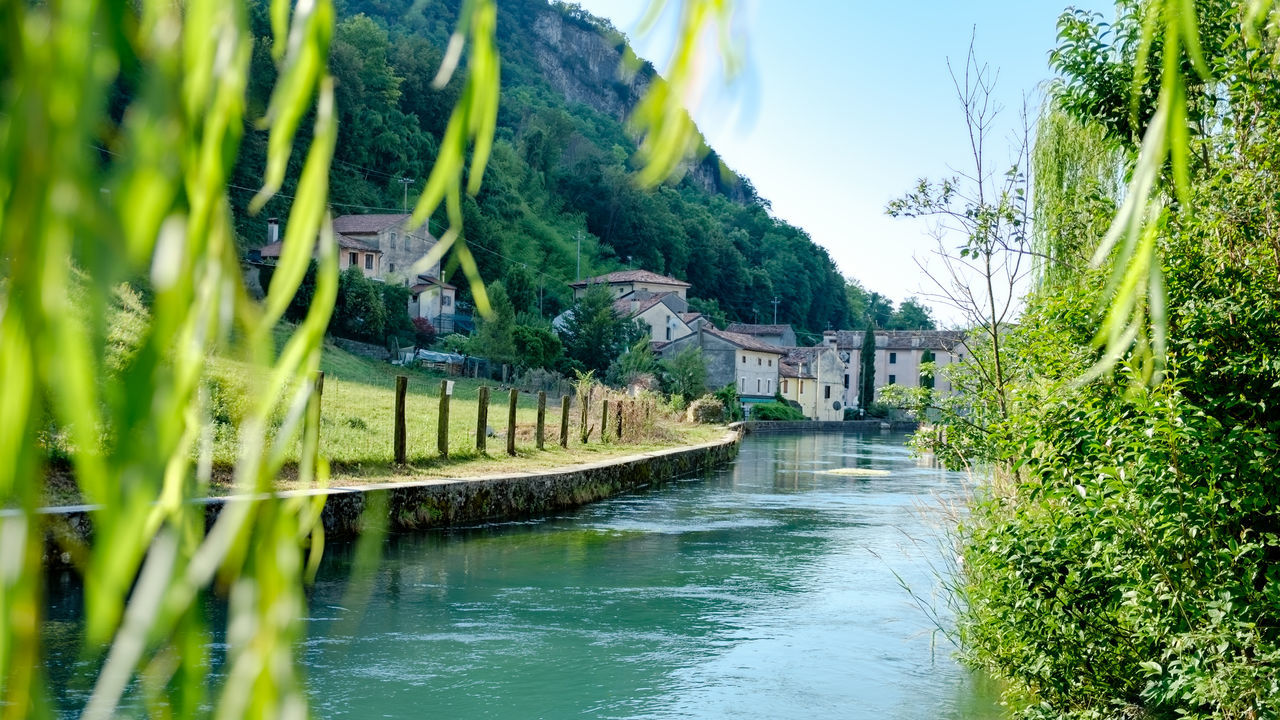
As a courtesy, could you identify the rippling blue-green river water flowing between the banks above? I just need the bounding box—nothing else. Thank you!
[50,433,1002,720]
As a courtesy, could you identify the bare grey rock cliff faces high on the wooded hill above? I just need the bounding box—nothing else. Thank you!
[530,6,754,202]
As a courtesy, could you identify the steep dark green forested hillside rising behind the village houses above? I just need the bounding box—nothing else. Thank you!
[233,0,880,333]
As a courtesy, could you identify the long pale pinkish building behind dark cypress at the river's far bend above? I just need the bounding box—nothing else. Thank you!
[822,331,965,407]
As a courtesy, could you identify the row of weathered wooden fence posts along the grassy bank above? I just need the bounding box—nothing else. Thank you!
[320,373,622,465]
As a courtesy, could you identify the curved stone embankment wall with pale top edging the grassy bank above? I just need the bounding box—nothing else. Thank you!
[40,428,742,565]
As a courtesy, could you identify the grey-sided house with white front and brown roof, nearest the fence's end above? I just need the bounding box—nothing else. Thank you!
[659,323,785,411]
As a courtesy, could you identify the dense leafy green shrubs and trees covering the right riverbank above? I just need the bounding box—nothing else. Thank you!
[916,3,1280,719]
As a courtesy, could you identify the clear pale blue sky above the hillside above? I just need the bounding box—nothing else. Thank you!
[570,0,1112,318]
